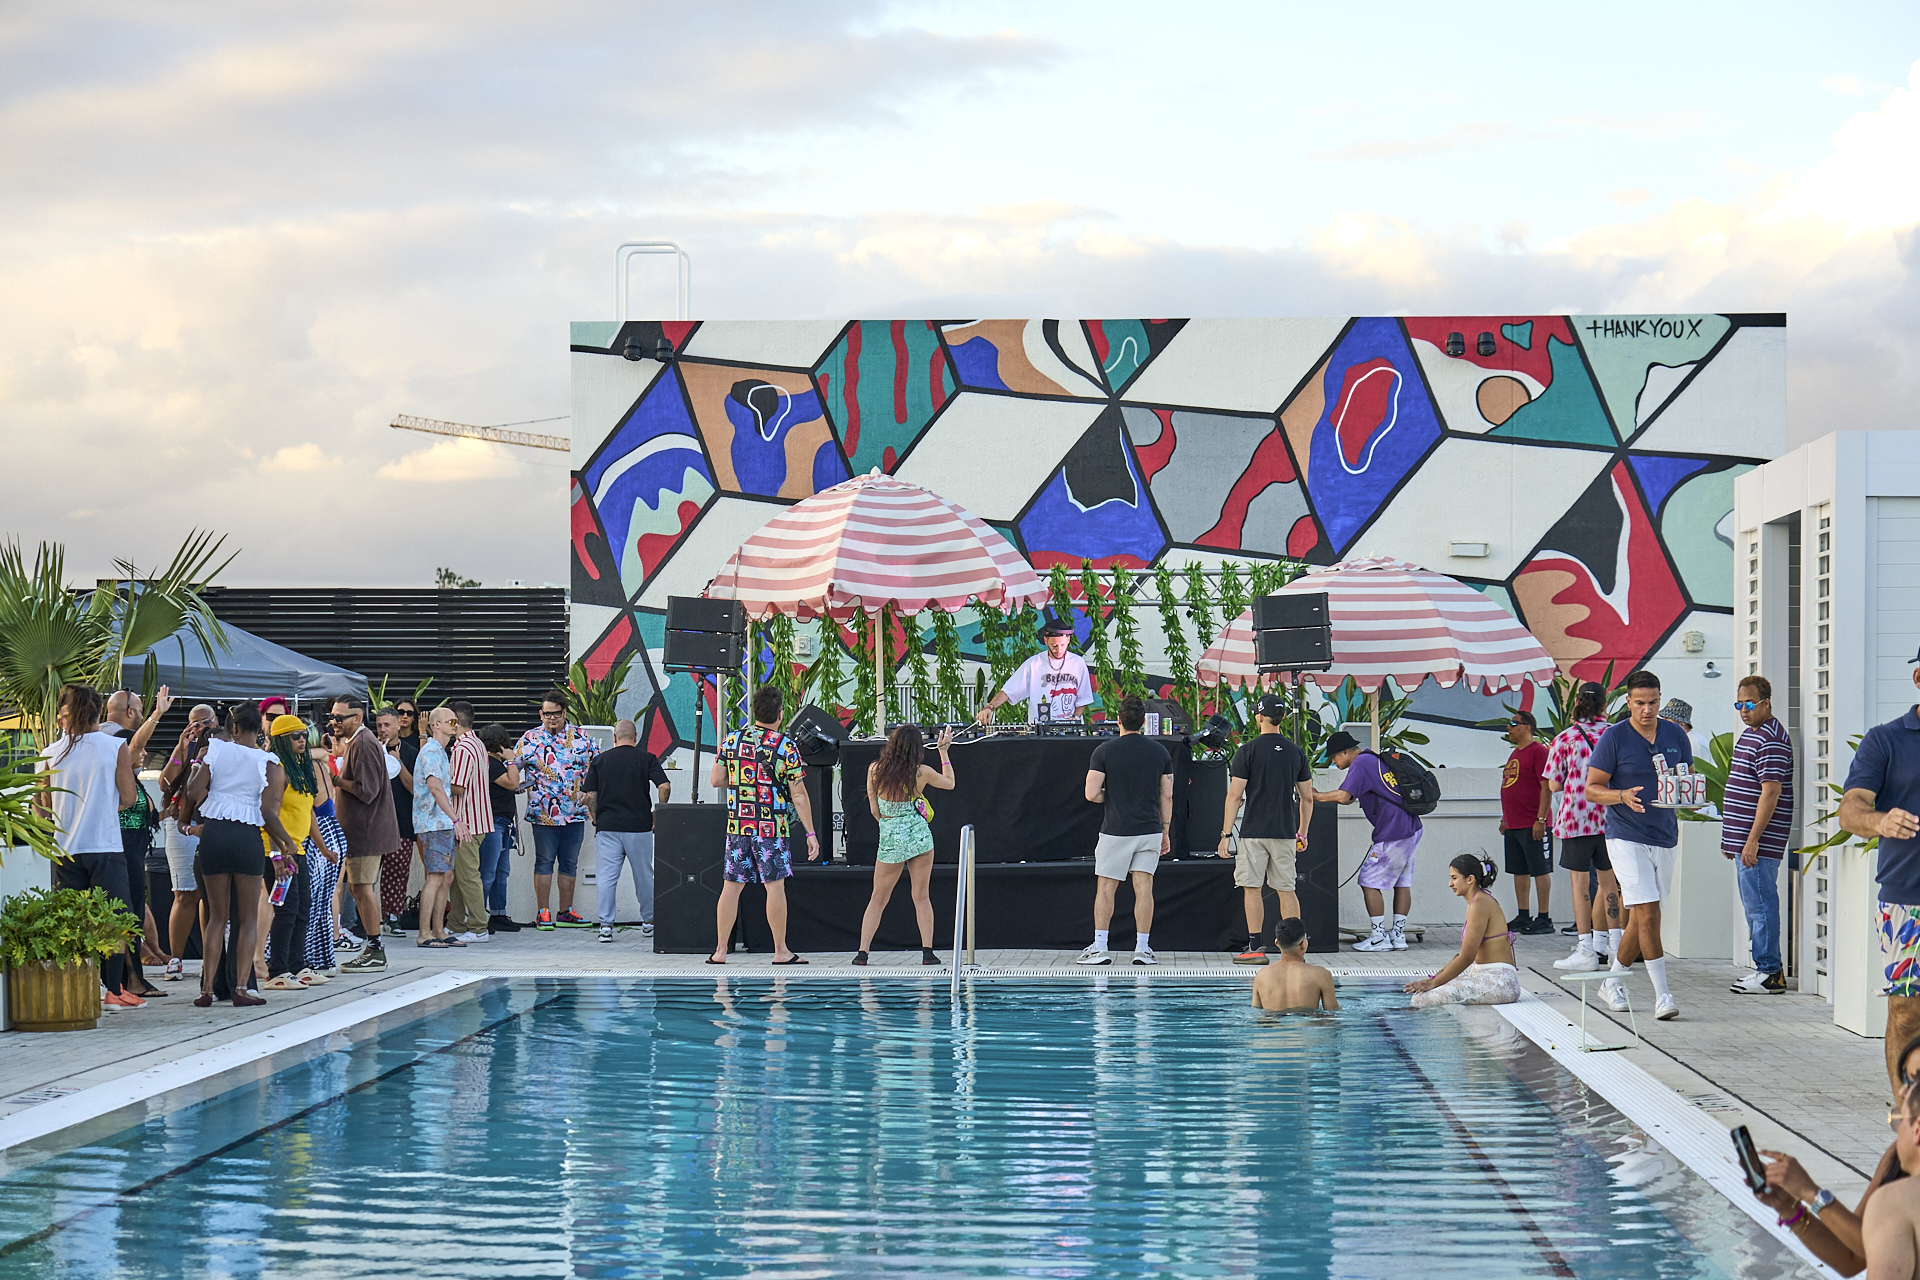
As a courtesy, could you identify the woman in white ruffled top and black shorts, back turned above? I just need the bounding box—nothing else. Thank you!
[186,702,294,1009]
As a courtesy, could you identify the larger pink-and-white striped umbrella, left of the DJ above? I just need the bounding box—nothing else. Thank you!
[707,470,1048,622]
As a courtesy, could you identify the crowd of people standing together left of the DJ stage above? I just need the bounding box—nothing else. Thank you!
[40,685,670,1009]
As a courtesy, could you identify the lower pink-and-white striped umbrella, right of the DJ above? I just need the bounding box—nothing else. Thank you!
[1196,557,1559,695]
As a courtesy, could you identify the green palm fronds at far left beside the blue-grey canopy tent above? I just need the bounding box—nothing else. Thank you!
[0,530,232,747]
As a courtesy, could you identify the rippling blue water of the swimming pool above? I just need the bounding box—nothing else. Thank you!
[0,979,1812,1280]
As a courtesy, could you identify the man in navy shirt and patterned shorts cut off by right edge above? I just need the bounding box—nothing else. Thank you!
[1839,654,1920,1090]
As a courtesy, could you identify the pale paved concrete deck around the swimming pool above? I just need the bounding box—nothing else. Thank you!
[0,929,1887,1201]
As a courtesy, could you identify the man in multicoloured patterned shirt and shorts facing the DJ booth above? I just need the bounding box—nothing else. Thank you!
[707,685,820,965]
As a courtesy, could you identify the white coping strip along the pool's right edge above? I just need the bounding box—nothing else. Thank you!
[1492,992,1839,1280]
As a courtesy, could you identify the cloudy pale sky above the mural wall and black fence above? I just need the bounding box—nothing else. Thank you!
[0,0,1920,585]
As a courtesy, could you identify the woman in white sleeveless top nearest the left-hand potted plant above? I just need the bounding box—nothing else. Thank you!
[40,685,146,1009]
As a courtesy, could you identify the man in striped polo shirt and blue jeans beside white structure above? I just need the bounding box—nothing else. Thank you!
[1720,676,1793,996]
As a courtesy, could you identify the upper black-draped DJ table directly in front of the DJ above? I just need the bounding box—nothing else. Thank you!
[841,737,1198,865]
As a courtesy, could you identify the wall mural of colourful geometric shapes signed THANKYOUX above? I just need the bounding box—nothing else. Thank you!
[572,315,1786,764]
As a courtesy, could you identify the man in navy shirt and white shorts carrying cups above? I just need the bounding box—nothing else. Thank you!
[1586,672,1693,1021]
